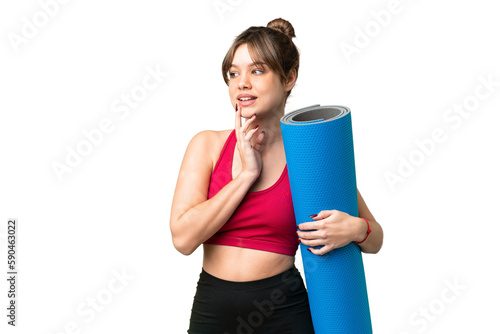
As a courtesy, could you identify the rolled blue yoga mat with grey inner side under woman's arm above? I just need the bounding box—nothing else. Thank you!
[281,105,372,334]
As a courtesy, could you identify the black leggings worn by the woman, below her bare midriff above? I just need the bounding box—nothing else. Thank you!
[188,266,314,334]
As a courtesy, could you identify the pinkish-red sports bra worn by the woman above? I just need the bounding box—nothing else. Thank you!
[204,130,298,255]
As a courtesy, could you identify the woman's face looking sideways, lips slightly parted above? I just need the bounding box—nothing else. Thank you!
[229,44,286,118]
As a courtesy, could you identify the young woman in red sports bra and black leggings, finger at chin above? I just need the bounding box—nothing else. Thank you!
[170,19,383,334]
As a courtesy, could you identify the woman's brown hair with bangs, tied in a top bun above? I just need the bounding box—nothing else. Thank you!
[222,18,300,98]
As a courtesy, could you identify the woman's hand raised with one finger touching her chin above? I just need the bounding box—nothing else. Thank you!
[234,103,265,181]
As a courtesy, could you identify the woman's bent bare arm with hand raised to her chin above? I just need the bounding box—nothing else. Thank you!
[170,105,263,255]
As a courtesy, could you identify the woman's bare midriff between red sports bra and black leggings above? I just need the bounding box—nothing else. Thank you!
[203,244,295,282]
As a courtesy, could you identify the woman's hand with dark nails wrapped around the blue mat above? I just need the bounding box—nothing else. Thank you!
[297,210,368,255]
